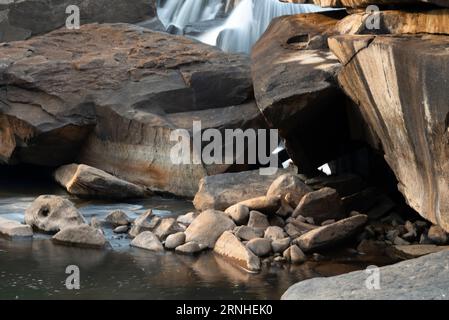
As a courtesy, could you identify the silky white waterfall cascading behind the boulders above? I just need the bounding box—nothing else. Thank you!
[159,0,329,53]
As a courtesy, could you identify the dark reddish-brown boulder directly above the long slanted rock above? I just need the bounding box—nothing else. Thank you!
[292,188,343,224]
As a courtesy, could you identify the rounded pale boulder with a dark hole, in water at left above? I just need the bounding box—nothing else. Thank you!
[25,195,86,233]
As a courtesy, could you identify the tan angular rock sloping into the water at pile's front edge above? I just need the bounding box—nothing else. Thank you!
[214,231,260,271]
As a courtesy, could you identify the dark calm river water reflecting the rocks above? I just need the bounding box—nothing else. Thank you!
[0,172,389,300]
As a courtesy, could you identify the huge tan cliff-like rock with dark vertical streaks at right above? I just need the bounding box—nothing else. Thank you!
[329,35,449,231]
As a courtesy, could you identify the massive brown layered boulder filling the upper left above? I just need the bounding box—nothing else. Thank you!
[0,24,260,197]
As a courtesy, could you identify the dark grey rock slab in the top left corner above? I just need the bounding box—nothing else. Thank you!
[0,0,156,42]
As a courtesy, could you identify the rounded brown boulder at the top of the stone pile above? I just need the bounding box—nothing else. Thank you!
[267,174,312,208]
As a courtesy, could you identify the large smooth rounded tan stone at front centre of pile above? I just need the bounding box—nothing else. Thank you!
[185,210,236,248]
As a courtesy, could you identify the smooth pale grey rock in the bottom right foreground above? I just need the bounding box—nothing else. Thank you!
[281,251,449,300]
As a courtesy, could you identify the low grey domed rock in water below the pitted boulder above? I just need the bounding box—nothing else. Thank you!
[52,224,107,248]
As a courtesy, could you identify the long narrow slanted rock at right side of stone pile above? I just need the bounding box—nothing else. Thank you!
[295,215,368,252]
